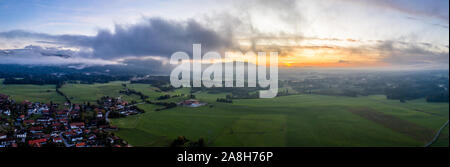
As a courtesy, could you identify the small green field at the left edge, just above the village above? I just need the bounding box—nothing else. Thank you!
[0,79,65,103]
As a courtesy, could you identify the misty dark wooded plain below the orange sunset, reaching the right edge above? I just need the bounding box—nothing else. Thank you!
[286,71,449,102]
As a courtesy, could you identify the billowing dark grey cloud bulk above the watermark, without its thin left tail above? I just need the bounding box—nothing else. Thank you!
[88,18,232,59]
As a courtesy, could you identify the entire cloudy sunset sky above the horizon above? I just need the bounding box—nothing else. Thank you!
[0,0,449,69]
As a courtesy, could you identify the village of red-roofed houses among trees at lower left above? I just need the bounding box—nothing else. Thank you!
[0,94,128,147]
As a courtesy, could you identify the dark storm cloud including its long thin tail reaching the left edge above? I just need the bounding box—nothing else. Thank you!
[0,18,236,59]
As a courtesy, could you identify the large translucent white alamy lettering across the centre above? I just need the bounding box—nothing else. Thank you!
[170,44,278,98]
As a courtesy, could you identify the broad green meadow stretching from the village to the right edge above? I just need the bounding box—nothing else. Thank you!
[113,89,449,146]
